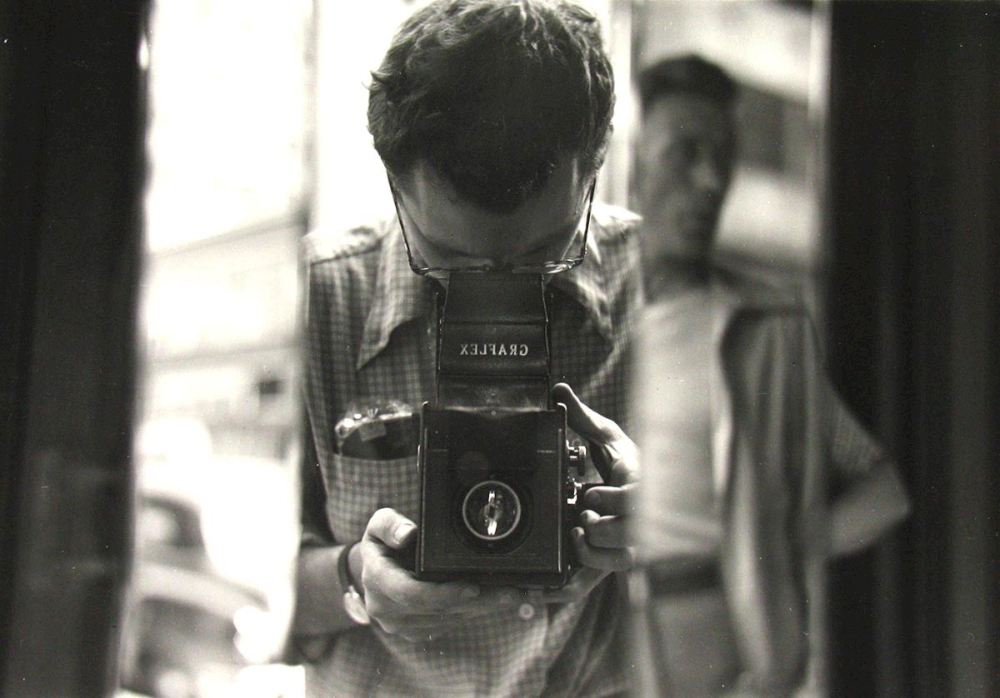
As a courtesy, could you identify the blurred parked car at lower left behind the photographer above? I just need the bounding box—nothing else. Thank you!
[120,438,294,698]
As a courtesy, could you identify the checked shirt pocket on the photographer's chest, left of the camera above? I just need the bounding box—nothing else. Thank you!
[322,454,420,543]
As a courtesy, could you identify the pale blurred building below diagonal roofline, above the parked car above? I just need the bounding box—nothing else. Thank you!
[143,220,303,459]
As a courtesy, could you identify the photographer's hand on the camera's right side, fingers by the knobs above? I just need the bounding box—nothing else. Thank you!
[546,383,639,601]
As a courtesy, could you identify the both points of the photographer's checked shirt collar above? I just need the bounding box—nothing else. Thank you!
[357,220,612,369]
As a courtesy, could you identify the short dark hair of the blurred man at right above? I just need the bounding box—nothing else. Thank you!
[637,54,739,111]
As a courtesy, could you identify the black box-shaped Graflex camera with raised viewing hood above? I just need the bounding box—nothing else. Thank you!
[415,272,586,588]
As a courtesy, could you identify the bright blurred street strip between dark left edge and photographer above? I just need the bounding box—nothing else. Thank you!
[121,0,314,698]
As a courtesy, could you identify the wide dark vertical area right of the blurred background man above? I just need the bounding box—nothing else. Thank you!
[827,2,1000,696]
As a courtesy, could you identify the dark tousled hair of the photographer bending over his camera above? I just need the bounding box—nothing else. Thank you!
[368,0,614,212]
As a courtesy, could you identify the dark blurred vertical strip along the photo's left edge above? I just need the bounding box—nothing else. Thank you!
[0,0,145,697]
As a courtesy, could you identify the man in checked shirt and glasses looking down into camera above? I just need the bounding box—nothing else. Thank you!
[293,0,640,696]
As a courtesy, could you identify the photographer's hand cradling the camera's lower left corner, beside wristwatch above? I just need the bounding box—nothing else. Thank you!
[352,509,520,641]
